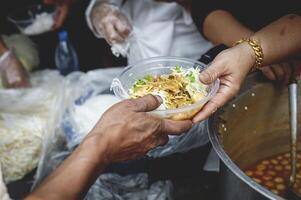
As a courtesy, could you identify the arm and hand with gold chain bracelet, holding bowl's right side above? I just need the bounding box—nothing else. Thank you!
[193,15,301,122]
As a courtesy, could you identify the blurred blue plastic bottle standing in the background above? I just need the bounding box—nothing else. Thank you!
[55,31,79,76]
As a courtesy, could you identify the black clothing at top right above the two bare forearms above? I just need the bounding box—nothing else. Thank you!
[191,0,301,36]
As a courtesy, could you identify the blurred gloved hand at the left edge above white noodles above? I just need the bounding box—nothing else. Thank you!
[0,51,30,88]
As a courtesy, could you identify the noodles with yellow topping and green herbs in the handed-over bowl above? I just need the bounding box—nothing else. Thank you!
[129,65,208,109]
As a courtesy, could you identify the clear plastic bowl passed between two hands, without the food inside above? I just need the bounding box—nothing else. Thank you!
[111,56,219,120]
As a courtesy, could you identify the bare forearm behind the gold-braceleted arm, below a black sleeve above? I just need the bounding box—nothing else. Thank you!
[203,10,253,47]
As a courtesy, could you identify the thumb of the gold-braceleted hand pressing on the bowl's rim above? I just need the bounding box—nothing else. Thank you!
[199,62,224,85]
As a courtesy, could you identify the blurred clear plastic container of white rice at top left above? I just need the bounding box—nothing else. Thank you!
[8,4,55,35]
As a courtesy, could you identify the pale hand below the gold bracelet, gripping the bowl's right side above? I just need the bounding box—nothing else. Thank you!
[193,43,255,122]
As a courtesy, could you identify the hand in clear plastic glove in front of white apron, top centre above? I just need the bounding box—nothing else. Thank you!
[91,2,132,44]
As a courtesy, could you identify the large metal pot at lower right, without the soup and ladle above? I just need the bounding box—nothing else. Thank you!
[209,73,301,200]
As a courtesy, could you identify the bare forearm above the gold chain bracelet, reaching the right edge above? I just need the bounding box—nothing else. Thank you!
[251,15,301,66]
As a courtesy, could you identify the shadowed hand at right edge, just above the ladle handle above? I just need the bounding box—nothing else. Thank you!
[259,60,301,85]
